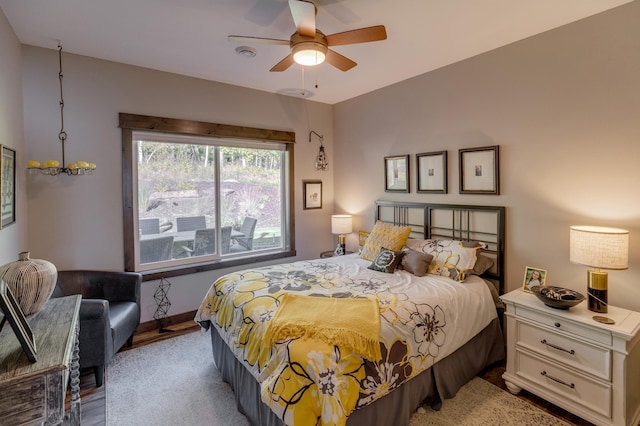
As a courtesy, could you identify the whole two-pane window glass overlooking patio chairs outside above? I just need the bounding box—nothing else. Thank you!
[134,133,287,269]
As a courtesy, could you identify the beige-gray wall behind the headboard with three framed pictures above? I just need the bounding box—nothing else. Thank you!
[334,1,640,310]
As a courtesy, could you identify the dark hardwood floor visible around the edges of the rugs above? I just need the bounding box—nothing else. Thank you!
[67,321,593,426]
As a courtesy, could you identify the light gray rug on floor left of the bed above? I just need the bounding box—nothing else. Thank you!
[105,332,249,426]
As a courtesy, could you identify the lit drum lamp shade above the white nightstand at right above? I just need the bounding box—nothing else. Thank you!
[569,226,629,269]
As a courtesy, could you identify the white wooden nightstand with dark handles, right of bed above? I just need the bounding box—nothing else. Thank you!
[501,289,640,426]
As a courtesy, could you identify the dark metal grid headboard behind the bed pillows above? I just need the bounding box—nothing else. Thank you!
[375,200,505,294]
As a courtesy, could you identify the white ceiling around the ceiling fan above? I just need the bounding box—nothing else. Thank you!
[0,0,631,104]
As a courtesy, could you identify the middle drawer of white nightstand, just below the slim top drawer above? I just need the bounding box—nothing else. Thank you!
[516,321,611,380]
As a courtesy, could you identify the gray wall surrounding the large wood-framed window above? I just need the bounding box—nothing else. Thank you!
[20,46,334,321]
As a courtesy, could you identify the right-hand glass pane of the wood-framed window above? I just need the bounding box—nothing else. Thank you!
[220,147,284,254]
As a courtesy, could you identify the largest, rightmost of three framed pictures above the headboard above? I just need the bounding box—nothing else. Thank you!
[458,145,500,195]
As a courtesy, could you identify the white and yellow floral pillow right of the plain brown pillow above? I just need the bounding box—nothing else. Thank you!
[409,240,484,281]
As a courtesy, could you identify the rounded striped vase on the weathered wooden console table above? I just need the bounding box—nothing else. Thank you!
[0,251,58,315]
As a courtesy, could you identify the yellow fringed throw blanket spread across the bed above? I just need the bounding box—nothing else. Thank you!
[266,293,382,361]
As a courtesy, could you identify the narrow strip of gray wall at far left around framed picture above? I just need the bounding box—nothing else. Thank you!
[0,10,27,265]
